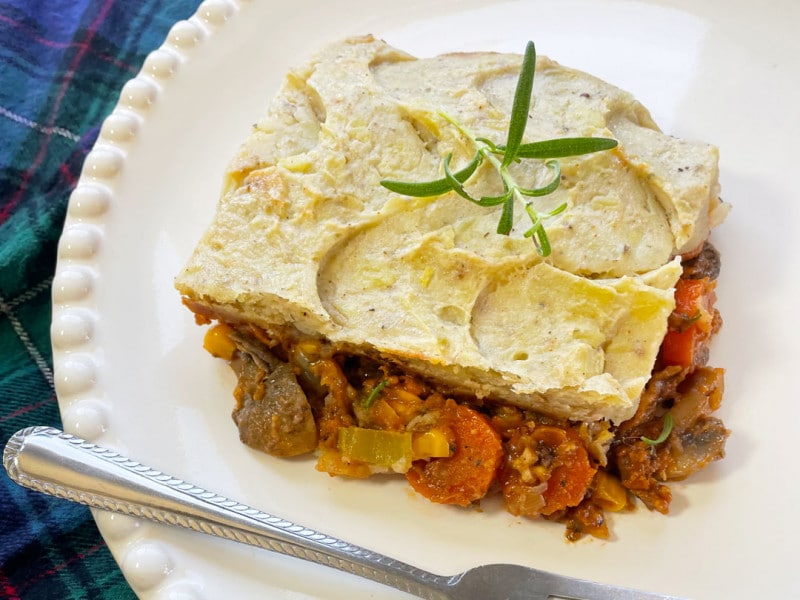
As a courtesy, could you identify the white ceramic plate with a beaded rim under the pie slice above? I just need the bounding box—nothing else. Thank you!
[52,0,800,599]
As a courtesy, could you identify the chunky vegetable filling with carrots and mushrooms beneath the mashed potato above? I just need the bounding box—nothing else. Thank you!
[192,244,729,540]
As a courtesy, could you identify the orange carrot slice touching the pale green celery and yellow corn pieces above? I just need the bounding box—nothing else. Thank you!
[406,401,503,506]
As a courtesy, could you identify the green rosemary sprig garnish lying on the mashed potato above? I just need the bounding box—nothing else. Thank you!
[381,42,617,256]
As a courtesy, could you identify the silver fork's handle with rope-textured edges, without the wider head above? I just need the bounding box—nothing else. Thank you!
[3,427,451,600]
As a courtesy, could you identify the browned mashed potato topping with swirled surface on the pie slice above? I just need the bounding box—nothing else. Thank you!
[177,37,724,423]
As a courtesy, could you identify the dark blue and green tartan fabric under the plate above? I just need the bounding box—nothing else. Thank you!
[0,0,205,600]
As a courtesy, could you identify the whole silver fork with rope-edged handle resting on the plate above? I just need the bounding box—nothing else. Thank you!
[3,427,677,600]
